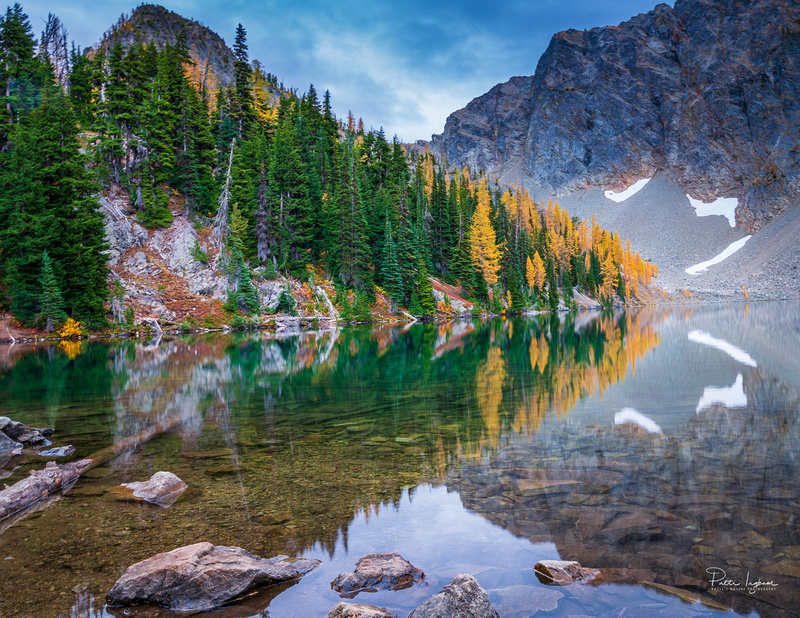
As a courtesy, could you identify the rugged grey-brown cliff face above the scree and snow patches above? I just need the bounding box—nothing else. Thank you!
[431,0,800,230]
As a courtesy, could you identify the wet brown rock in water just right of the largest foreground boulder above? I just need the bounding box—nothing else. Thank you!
[331,552,425,599]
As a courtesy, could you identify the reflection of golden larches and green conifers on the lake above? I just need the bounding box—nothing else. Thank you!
[475,313,661,445]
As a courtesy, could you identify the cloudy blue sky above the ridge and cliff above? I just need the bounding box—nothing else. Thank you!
[20,0,672,141]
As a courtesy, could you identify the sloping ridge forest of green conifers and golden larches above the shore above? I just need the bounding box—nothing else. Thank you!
[0,4,655,329]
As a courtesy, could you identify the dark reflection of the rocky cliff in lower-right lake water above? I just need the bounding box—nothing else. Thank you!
[448,370,800,616]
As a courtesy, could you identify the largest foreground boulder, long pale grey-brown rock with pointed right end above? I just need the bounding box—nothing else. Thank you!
[106,543,319,611]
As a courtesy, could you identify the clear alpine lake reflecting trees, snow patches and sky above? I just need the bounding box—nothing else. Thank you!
[0,302,800,618]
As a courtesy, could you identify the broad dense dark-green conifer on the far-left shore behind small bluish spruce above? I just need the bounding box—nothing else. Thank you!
[0,87,108,324]
